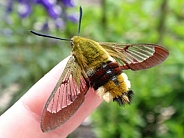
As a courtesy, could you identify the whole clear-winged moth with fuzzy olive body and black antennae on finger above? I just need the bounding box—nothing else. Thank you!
[31,7,169,132]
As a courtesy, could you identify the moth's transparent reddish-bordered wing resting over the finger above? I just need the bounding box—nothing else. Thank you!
[41,56,89,132]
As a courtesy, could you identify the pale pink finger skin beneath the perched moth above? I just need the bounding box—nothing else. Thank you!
[0,58,102,138]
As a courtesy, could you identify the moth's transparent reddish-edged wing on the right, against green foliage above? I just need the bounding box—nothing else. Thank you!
[99,42,169,70]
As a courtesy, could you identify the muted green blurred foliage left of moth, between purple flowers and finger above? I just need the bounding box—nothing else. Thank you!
[0,4,72,114]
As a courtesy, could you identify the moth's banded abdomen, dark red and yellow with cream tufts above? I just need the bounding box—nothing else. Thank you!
[89,61,133,105]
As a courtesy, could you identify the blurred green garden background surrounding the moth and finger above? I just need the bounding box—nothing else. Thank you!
[0,0,184,138]
